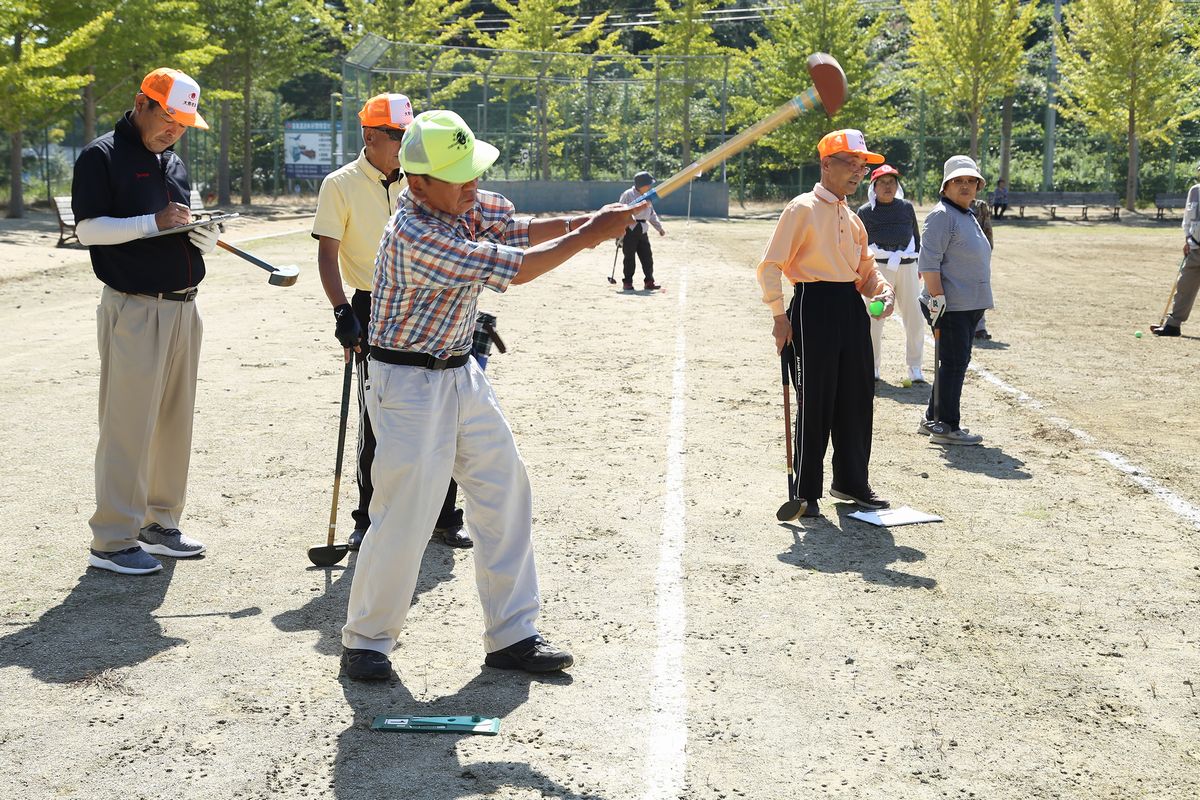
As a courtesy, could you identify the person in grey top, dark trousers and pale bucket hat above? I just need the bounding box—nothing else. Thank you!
[917,156,991,445]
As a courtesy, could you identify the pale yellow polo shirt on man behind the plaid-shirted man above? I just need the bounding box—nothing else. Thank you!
[312,150,408,291]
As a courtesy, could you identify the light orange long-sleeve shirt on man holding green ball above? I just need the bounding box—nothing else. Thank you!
[758,184,889,315]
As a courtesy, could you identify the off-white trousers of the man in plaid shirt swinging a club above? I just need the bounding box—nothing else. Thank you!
[342,359,541,654]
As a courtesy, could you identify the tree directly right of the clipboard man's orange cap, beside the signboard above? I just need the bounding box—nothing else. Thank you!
[199,0,336,204]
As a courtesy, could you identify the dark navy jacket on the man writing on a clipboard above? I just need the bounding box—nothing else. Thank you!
[71,112,204,293]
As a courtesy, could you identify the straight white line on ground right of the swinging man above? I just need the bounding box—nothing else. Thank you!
[644,266,688,800]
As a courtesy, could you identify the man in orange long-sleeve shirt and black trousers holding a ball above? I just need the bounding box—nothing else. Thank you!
[757,130,894,517]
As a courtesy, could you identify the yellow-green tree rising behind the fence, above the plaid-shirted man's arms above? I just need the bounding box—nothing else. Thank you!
[479,0,617,180]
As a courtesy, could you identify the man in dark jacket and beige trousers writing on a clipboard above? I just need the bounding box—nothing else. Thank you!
[71,67,217,575]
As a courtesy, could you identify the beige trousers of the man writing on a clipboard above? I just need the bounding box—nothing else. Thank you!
[89,287,204,553]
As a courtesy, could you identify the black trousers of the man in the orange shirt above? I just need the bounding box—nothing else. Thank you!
[788,282,875,500]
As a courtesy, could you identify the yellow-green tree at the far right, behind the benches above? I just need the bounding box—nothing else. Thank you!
[1058,0,1200,211]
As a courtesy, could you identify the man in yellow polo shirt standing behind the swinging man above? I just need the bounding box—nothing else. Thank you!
[312,94,472,549]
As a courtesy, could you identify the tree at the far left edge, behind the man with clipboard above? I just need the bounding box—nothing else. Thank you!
[0,0,113,218]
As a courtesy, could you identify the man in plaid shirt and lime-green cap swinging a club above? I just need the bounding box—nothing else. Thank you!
[342,110,643,680]
